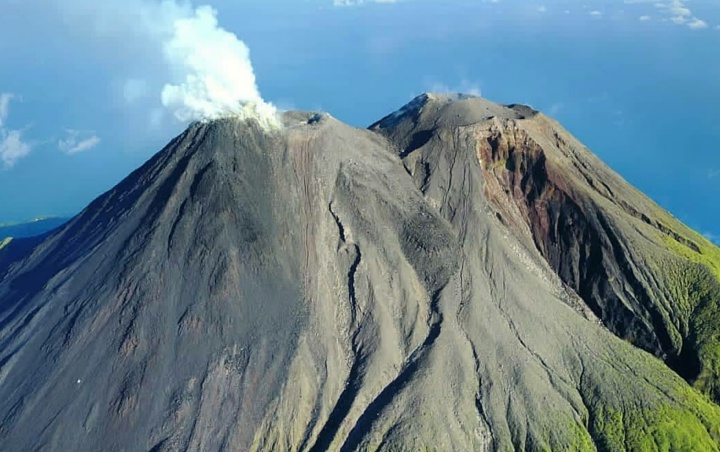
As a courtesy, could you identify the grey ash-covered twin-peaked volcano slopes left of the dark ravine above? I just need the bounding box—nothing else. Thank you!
[0,95,720,451]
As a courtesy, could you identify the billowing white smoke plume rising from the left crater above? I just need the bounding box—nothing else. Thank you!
[55,0,279,126]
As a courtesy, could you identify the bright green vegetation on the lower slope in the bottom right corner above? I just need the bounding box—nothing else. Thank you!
[581,342,720,452]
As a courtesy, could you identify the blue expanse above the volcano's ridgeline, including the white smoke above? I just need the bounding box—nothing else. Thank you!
[0,0,720,243]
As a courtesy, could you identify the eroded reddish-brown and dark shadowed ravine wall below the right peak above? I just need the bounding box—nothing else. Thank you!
[476,118,679,356]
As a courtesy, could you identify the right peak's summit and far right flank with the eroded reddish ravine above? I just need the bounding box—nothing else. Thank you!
[378,92,720,402]
